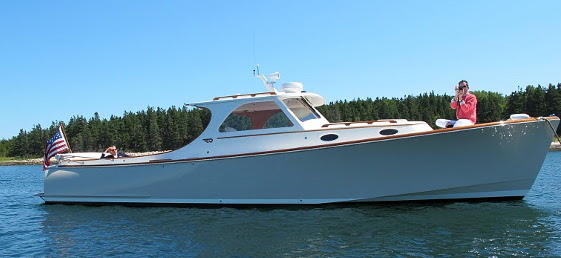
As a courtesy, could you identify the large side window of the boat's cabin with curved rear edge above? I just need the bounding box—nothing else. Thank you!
[218,101,293,132]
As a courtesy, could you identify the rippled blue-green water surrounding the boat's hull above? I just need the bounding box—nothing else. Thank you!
[0,152,561,257]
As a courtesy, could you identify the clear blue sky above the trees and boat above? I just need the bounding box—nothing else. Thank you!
[0,0,561,139]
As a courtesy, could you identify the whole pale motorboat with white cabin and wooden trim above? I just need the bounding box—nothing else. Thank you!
[40,71,559,205]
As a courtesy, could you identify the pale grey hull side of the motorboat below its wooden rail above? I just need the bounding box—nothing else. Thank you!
[44,120,558,204]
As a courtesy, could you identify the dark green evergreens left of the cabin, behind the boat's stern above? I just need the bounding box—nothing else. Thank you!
[0,107,210,157]
